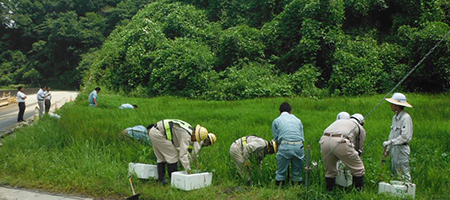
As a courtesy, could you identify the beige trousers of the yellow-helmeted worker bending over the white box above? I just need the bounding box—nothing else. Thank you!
[149,127,178,164]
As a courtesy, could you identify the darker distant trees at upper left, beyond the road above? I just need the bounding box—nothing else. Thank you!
[0,0,148,89]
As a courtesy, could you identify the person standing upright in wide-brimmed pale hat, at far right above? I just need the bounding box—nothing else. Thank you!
[383,93,413,182]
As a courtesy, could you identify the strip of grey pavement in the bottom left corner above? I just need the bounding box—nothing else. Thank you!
[0,187,92,200]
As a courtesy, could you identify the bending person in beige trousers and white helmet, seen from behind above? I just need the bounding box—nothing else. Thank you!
[319,114,366,191]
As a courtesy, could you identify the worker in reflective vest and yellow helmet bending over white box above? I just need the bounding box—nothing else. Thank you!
[149,119,208,184]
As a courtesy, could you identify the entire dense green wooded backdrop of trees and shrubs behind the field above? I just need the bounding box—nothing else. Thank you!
[0,0,450,99]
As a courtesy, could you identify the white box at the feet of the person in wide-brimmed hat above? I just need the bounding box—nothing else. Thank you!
[378,181,416,198]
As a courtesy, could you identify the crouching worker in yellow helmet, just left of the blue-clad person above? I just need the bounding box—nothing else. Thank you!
[230,135,277,185]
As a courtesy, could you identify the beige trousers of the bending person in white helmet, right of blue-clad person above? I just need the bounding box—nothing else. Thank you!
[320,135,365,178]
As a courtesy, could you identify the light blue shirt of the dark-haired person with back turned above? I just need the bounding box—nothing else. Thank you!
[272,112,305,144]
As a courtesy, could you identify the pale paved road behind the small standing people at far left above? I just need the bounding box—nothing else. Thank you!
[0,91,78,133]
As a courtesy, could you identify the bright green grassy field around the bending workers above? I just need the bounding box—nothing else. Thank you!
[0,92,450,199]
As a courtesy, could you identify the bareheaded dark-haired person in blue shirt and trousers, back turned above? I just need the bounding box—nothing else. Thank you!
[272,102,305,186]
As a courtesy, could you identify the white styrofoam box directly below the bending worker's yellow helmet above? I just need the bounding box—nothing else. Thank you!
[171,171,212,191]
